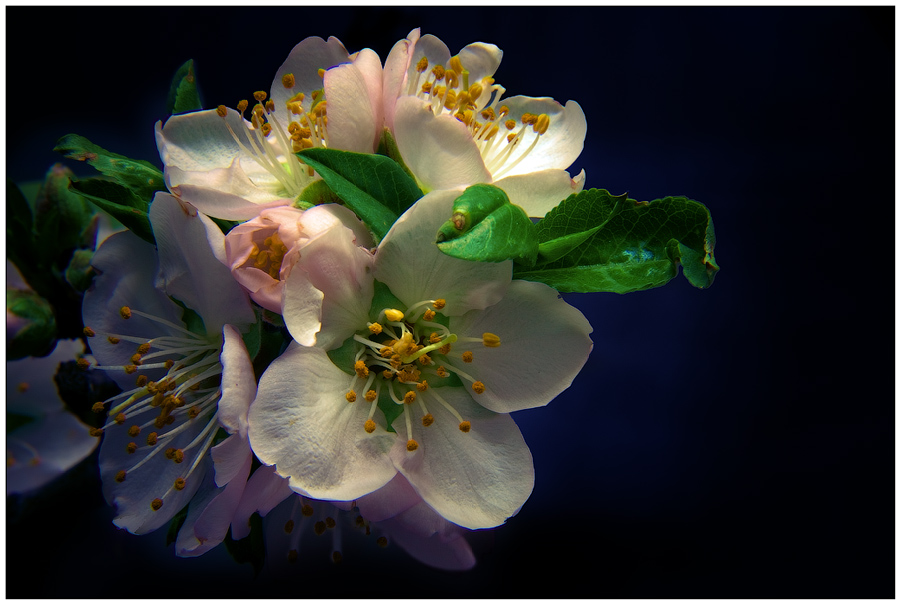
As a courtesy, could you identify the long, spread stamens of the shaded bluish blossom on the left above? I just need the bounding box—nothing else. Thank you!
[79,306,222,511]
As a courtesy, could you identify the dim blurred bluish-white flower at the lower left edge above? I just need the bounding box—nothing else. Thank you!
[6,340,97,495]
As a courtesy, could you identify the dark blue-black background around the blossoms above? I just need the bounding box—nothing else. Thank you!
[6,7,895,598]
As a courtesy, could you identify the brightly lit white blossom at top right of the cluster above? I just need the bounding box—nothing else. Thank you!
[383,29,587,217]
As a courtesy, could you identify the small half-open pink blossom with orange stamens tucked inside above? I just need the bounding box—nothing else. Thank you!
[225,204,374,313]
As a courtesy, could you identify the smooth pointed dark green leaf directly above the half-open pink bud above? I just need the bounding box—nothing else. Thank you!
[298,148,422,242]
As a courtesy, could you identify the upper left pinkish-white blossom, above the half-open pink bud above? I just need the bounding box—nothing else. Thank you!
[156,37,383,220]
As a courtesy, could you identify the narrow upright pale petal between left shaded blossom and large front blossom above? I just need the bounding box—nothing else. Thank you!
[219,325,256,438]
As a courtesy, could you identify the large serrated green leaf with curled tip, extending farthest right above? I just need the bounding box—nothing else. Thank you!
[513,189,719,294]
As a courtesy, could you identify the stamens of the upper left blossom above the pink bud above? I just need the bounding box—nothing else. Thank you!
[216,69,328,198]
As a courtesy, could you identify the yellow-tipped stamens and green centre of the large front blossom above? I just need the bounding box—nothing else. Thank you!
[346,299,500,452]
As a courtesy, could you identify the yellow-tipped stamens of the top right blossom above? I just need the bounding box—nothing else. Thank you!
[407,55,550,180]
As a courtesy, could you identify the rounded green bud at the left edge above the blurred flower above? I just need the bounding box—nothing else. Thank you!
[6,287,57,361]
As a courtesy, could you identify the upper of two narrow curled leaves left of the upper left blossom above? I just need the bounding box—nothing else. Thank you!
[53,134,166,203]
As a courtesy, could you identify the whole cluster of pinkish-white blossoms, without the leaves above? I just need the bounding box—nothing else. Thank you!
[14,30,592,569]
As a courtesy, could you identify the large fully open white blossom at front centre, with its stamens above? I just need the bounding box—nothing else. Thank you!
[248,191,592,529]
